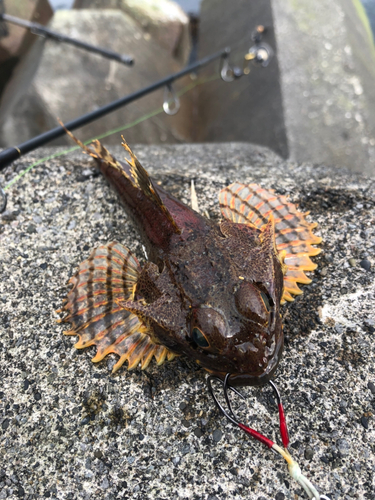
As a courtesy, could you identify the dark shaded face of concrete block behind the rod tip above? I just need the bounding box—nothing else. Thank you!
[200,0,289,158]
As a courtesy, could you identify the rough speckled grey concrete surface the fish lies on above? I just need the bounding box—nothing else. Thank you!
[0,144,375,500]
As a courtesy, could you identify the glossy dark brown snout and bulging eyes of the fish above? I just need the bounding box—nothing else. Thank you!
[189,280,283,385]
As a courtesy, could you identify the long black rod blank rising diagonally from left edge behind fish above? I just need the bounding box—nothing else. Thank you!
[0,49,229,171]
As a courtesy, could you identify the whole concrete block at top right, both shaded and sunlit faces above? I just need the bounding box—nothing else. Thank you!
[199,0,375,176]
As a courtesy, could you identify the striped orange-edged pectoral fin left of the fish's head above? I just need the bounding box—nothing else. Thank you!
[61,242,174,372]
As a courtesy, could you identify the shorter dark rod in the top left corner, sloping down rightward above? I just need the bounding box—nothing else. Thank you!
[0,13,134,66]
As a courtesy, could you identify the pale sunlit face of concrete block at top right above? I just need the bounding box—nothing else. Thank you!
[272,0,375,173]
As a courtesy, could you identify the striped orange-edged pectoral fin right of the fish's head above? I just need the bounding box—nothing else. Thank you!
[219,182,322,303]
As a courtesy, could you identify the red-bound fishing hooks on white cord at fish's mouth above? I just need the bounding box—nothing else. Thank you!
[207,373,330,500]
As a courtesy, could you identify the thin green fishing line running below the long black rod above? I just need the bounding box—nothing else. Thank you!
[4,74,220,191]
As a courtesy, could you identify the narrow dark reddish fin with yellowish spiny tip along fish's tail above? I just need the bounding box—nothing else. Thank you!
[122,136,181,234]
